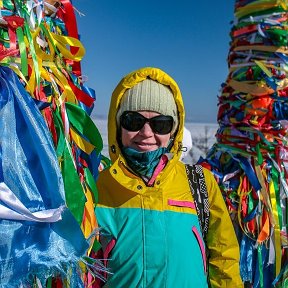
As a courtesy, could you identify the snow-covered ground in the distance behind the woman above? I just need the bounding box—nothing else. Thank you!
[93,117,218,163]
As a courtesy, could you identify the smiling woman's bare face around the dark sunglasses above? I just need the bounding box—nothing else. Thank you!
[121,111,171,152]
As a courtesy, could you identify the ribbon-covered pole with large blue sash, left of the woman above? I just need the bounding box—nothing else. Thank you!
[0,0,103,287]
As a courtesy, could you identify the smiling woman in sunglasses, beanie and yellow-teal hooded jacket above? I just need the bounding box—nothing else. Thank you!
[96,67,242,288]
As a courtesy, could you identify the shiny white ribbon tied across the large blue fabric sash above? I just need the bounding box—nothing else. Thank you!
[0,182,65,223]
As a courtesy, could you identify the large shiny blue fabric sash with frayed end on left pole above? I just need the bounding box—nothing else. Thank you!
[0,67,88,287]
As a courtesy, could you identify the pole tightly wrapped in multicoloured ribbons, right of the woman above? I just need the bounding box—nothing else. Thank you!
[199,0,288,288]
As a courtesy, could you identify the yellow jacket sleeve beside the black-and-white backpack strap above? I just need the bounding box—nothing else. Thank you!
[203,169,243,288]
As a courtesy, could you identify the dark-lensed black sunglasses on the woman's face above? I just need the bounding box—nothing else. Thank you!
[120,111,173,135]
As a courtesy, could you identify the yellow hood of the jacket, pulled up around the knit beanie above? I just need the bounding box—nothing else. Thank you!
[108,67,185,168]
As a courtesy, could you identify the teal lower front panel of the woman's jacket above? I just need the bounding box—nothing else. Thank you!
[96,207,207,288]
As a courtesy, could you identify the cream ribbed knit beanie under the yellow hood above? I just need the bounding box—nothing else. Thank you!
[116,79,178,134]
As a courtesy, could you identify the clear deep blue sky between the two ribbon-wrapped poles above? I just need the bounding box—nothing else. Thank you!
[73,0,234,123]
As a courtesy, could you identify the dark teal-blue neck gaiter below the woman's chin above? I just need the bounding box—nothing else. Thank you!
[122,147,169,178]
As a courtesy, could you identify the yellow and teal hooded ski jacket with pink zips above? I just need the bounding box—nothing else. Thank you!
[96,67,243,288]
